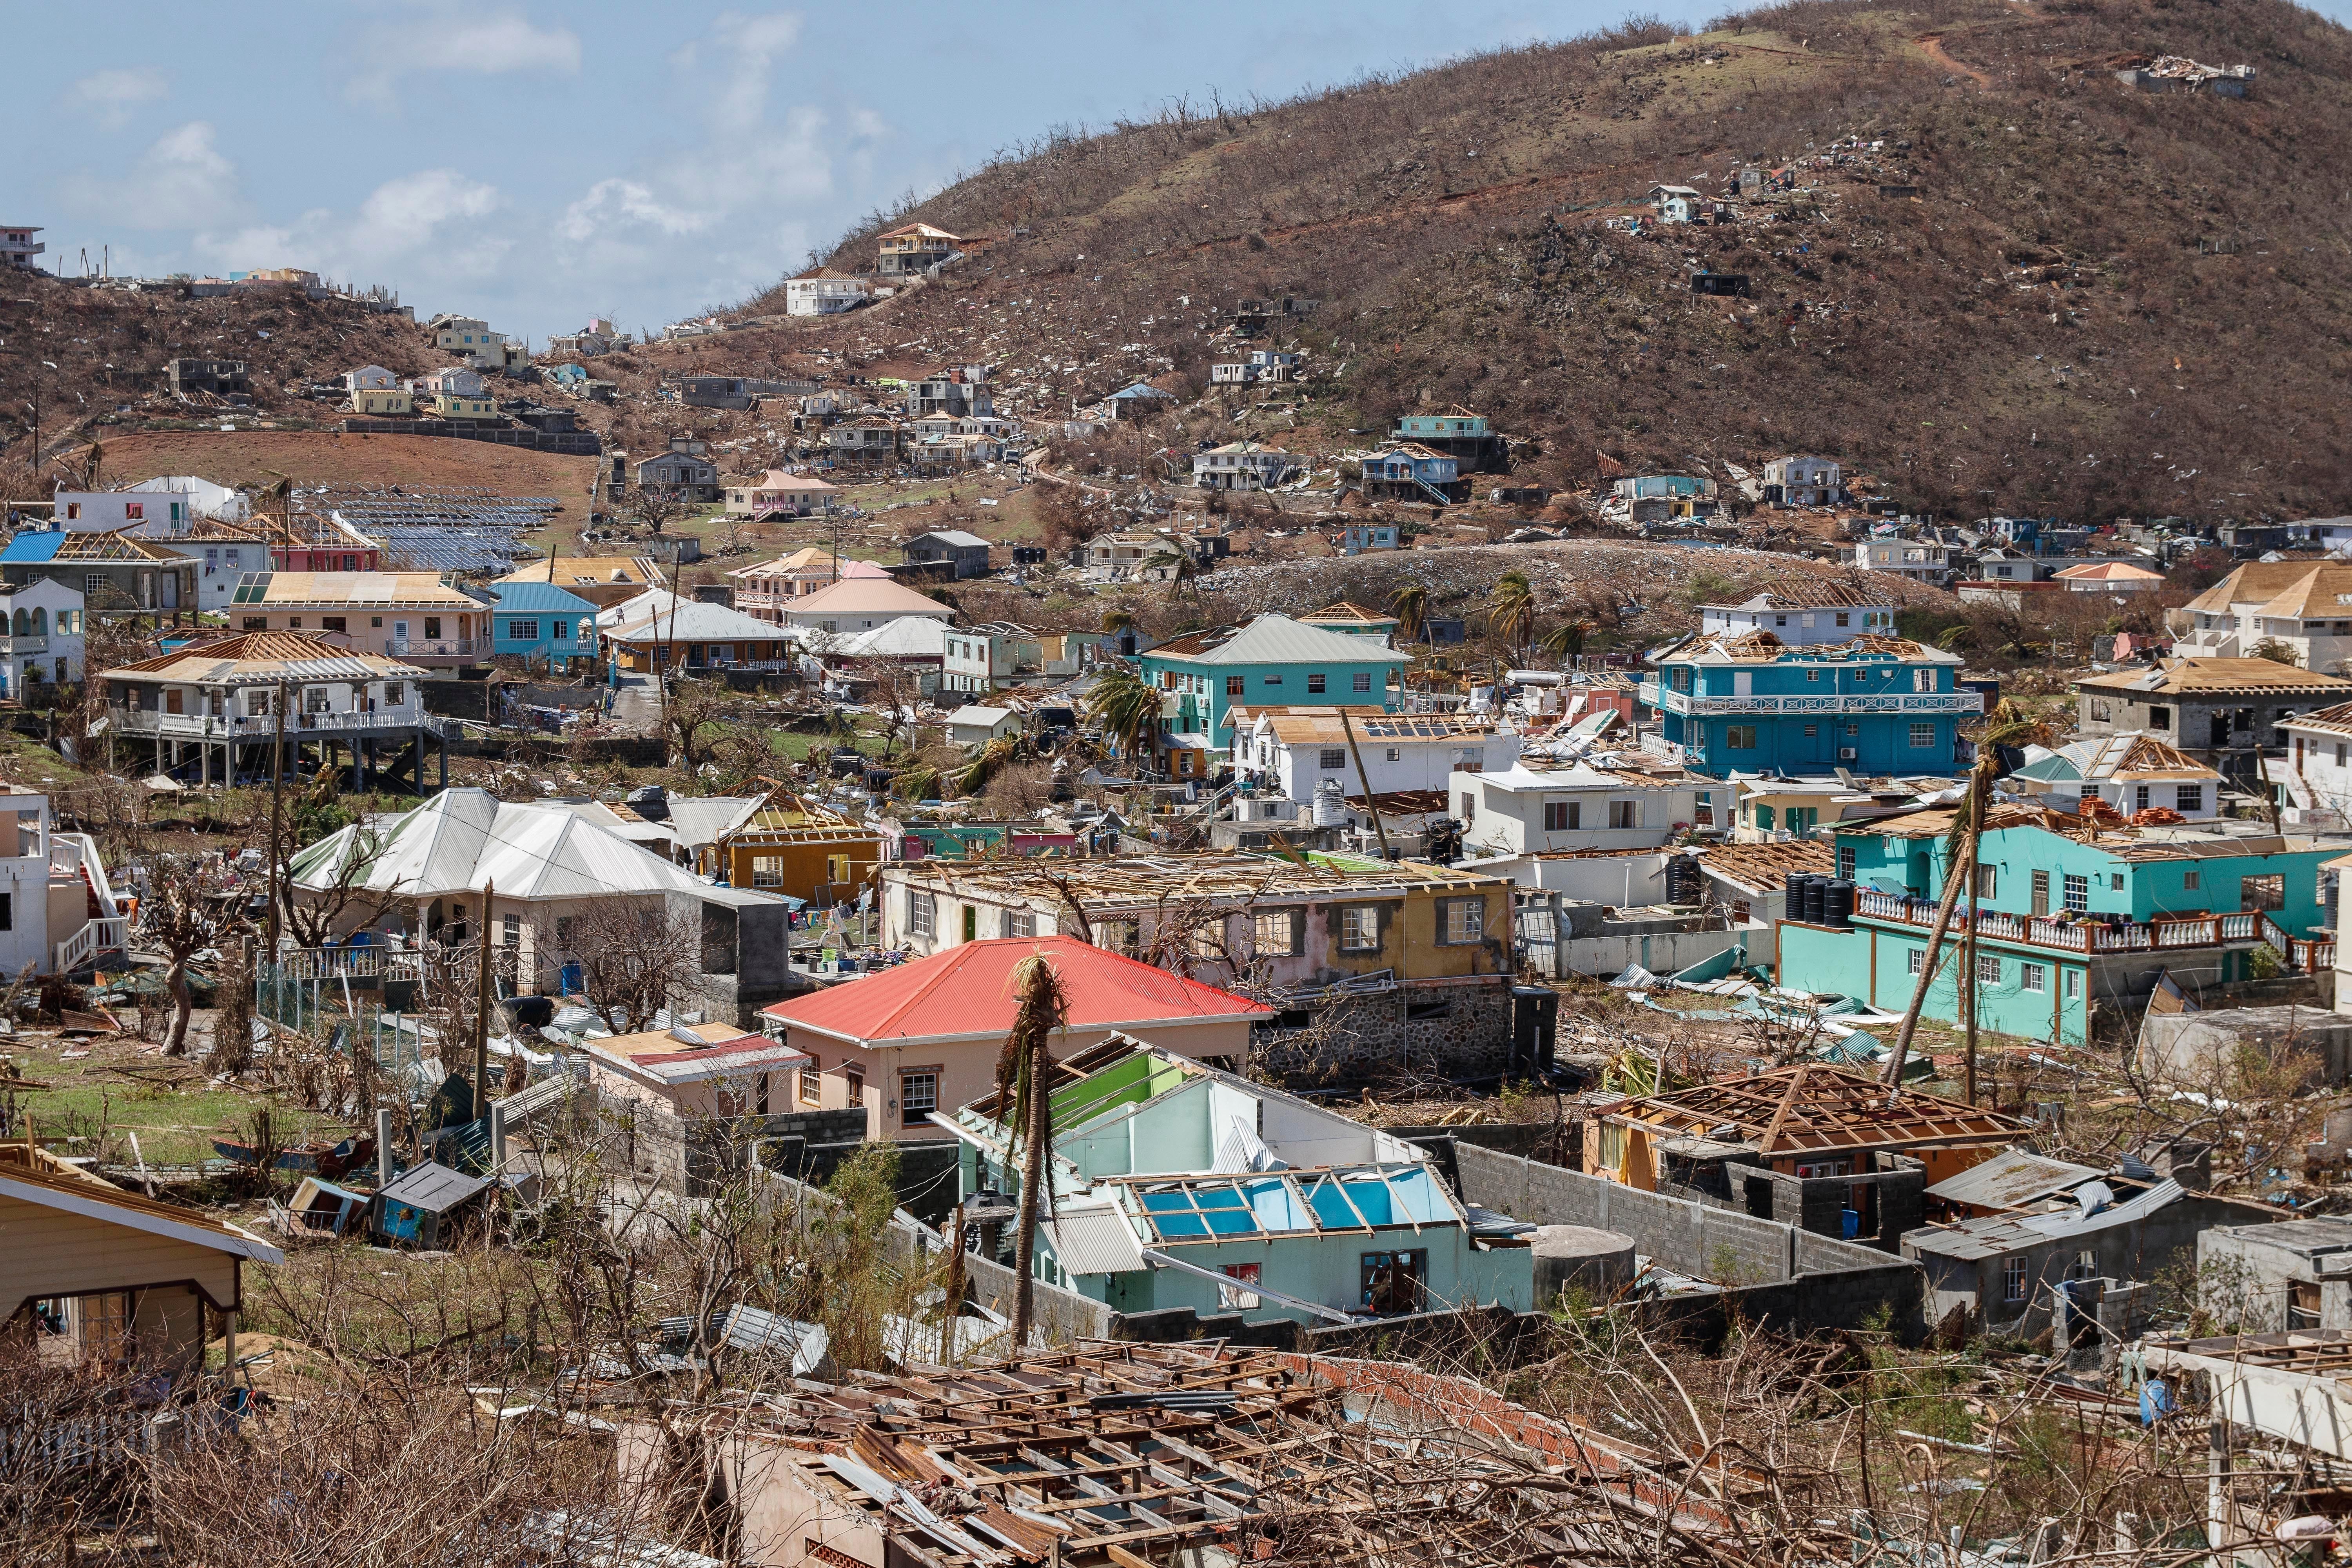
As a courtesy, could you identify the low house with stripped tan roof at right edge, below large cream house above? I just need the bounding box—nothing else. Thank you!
[2072,656,2352,780]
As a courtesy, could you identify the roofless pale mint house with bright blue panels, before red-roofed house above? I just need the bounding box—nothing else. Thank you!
[931,1034,1536,1326]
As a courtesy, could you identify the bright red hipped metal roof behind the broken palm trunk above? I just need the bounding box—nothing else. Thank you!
[762,936,1272,1044]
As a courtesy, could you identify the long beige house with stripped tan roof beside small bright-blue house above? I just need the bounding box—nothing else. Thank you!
[228,571,489,679]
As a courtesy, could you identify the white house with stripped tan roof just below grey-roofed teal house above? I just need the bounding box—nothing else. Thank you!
[1228,708,1519,806]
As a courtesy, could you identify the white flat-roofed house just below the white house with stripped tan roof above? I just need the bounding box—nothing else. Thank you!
[1454,762,1719,858]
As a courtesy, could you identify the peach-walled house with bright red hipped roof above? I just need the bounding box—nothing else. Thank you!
[762,936,1272,1138]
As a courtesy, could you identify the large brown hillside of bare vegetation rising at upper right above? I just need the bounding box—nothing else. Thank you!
[727,0,2352,519]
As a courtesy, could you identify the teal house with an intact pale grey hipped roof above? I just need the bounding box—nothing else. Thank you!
[1136,616,1404,752]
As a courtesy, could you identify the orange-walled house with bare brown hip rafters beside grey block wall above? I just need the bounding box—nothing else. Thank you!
[1585,1063,2032,1250]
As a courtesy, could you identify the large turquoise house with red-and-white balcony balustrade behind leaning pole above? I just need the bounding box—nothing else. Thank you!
[1778,809,2336,1046]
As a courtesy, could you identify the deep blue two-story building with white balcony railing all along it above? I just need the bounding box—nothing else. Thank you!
[1642,632,1985,778]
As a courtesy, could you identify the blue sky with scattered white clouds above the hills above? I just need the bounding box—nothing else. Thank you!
[0,0,2352,341]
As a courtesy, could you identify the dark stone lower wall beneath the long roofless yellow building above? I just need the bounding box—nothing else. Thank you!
[1256,976,1512,1089]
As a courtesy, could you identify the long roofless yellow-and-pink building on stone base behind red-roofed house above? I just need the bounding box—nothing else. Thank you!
[861,853,1515,1077]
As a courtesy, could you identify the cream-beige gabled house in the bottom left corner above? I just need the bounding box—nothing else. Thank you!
[0,1143,285,1375]
